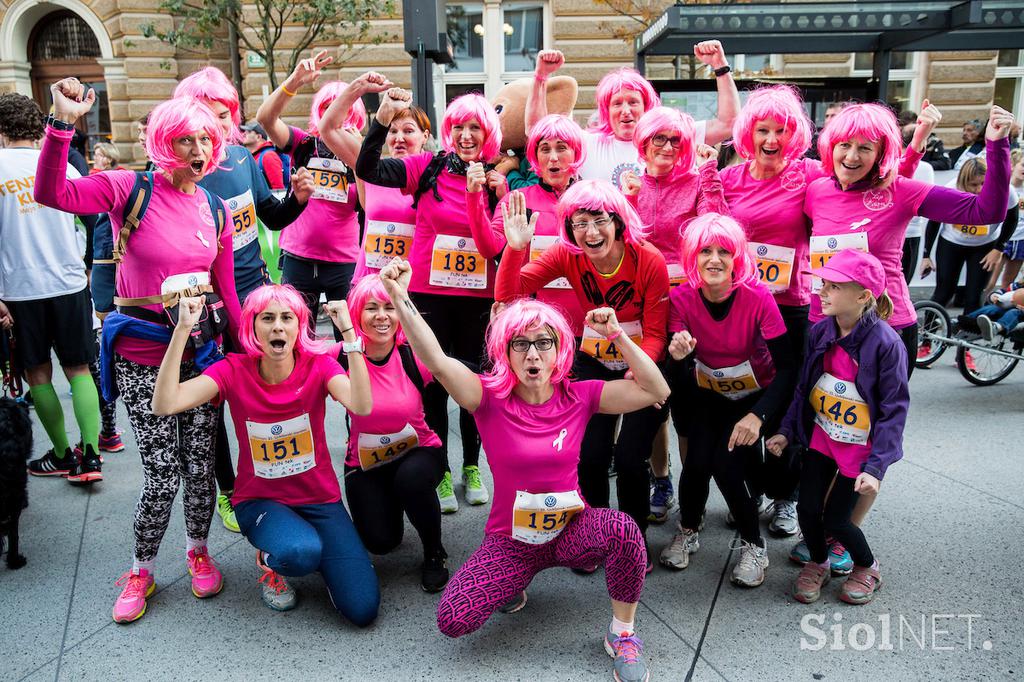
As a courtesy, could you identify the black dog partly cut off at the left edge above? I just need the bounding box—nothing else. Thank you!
[0,397,32,568]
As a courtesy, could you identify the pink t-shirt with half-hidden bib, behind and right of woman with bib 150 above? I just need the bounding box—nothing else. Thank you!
[720,159,824,306]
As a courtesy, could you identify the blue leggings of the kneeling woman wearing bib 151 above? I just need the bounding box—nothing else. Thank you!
[234,500,381,628]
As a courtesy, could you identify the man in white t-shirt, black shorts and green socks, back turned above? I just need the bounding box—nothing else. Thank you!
[0,93,102,484]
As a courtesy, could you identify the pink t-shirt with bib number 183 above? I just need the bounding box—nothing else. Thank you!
[401,152,495,298]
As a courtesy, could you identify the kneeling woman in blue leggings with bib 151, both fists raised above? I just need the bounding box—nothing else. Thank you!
[153,285,380,627]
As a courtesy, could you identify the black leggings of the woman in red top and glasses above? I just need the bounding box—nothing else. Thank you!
[573,351,669,535]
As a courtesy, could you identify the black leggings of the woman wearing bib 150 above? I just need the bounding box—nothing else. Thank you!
[679,389,765,546]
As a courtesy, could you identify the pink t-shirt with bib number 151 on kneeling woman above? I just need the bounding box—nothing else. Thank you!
[203,353,344,507]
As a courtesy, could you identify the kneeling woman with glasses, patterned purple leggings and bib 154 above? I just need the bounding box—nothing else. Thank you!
[380,259,669,680]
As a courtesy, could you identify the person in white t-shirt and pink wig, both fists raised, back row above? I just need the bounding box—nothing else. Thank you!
[526,40,740,187]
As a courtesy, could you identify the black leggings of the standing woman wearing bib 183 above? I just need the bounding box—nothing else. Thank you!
[413,293,492,470]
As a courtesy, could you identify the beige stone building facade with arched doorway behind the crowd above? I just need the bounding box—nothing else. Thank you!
[0,0,1024,162]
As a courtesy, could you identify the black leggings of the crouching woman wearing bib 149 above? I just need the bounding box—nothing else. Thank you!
[345,447,444,554]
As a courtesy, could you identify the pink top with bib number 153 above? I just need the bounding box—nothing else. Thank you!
[352,182,416,282]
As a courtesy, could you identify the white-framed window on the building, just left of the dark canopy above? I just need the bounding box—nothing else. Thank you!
[438,0,550,106]
